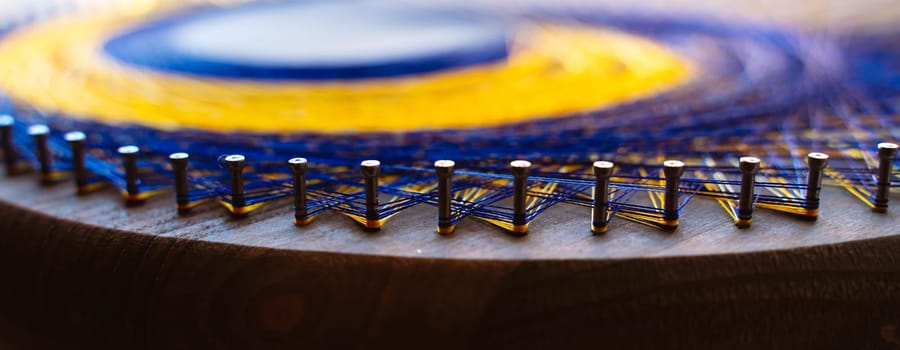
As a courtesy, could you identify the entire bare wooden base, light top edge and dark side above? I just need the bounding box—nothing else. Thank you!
[0,170,900,349]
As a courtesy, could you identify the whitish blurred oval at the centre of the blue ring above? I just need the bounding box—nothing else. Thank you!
[166,2,504,67]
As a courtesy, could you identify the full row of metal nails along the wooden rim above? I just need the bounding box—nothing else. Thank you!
[0,117,897,234]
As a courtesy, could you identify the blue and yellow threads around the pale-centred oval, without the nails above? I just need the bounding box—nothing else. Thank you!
[0,2,900,232]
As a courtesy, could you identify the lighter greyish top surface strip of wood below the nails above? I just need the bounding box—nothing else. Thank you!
[0,171,900,260]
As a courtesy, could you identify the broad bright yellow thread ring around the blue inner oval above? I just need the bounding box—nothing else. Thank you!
[0,10,693,133]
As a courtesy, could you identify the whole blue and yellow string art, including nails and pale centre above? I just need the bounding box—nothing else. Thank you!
[0,1,900,234]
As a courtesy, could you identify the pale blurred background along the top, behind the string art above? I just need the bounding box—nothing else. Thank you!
[0,0,900,31]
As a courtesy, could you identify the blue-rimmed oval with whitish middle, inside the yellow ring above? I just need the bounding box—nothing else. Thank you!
[104,1,508,80]
